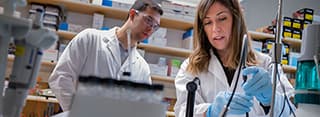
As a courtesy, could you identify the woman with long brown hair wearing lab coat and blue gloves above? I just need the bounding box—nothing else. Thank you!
[174,0,295,117]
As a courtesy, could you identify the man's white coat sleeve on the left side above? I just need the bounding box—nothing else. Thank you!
[48,29,90,111]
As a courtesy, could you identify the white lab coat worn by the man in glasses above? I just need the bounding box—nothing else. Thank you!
[49,27,151,111]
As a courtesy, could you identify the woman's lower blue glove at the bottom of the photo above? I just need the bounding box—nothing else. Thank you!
[206,91,253,117]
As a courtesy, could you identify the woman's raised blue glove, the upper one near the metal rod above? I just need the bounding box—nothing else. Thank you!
[242,66,272,106]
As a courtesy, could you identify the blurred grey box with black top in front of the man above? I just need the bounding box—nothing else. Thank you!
[69,76,166,117]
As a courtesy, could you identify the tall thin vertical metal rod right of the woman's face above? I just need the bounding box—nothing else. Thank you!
[270,0,282,117]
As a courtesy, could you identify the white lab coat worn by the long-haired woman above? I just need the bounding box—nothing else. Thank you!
[174,51,293,117]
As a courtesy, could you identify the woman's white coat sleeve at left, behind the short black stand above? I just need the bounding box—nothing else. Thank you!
[174,59,210,117]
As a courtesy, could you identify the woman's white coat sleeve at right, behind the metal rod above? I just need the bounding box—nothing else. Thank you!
[264,53,296,117]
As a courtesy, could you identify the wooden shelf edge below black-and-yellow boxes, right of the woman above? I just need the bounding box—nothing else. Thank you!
[249,31,301,48]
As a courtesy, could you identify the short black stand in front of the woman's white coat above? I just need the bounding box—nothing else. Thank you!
[186,77,200,117]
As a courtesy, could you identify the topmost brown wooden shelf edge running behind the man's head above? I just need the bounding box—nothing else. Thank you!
[28,0,193,30]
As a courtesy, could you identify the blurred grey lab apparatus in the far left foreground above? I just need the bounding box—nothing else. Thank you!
[0,0,58,117]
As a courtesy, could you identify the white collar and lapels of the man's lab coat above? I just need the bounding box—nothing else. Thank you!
[107,27,138,66]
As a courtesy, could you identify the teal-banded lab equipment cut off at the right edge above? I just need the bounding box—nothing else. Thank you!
[294,24,320,117]
